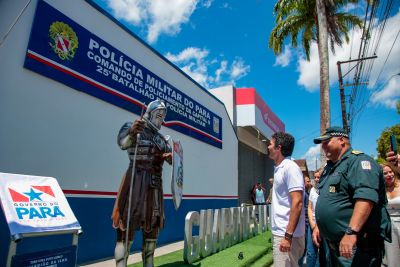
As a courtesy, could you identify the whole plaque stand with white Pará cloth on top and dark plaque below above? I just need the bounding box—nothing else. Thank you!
[0,172,83,267]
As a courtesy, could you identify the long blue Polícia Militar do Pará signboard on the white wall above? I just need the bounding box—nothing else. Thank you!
[24,1,222,148]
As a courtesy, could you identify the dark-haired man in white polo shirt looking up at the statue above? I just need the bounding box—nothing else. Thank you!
[268,132,305,266]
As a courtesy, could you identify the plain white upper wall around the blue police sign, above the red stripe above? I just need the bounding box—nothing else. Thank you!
[0,0,238,195]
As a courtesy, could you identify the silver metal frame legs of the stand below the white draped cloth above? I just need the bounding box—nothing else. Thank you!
[6,229,83,267]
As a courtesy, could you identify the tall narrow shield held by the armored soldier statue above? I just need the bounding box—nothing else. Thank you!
[171,140,183,209]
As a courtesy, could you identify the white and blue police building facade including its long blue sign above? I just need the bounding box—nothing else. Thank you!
[0,0,239,266]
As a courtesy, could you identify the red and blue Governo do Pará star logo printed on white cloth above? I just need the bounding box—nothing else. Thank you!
[8,185,65,220]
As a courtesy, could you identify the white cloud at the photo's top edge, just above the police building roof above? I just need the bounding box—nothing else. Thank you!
[108,0,200,43]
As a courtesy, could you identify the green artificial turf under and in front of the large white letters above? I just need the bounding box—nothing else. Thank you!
[129,231,272,267]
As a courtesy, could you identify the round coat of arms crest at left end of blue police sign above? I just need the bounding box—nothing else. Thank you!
[49,21,79,60]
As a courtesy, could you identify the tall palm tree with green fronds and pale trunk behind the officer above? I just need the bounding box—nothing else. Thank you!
[268,0,362,161]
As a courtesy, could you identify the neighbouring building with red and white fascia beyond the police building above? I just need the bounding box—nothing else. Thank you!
[210,86,285,204]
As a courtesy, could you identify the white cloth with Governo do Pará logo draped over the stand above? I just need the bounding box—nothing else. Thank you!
[0,172,81,235]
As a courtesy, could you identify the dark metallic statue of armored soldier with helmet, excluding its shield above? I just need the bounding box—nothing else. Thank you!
[112,100,172,267]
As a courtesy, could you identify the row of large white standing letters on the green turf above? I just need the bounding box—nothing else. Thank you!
[183,205,270,264]
